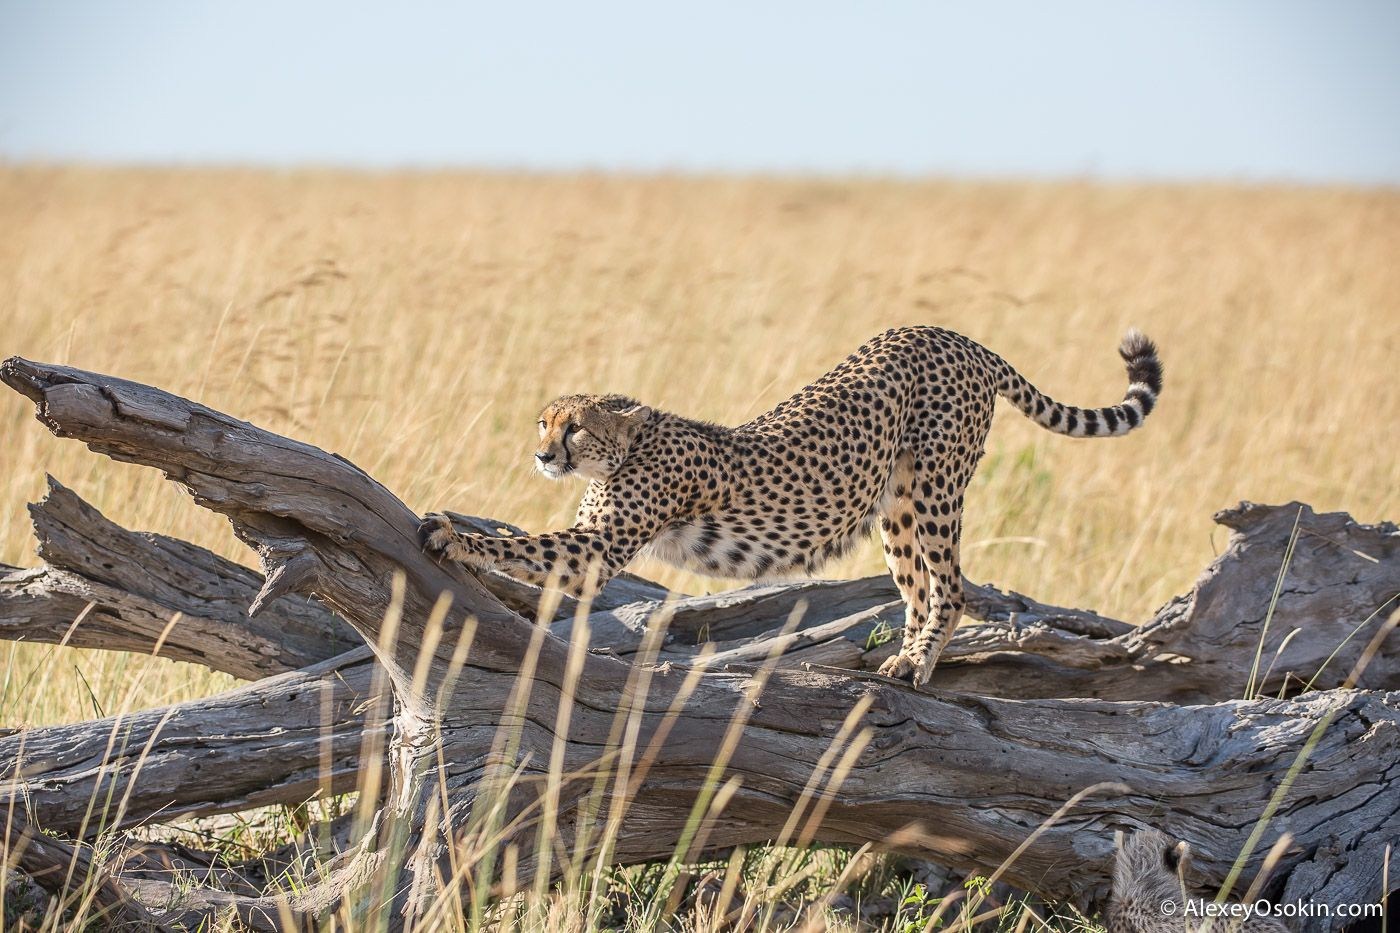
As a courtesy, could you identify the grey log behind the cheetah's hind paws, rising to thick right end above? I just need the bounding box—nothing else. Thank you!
[553,503,1400,694]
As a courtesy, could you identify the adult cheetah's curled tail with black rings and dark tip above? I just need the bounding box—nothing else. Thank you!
[997,329,1162,437]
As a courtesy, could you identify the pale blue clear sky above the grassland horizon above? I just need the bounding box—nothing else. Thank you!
[0,0,1400,185]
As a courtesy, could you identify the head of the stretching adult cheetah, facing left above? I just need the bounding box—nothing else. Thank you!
[535,395,651,479]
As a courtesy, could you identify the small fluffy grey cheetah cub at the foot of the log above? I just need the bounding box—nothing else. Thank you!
[1106,829,1288,933]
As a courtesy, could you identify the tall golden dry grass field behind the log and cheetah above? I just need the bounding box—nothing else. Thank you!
[0,168,1400,924]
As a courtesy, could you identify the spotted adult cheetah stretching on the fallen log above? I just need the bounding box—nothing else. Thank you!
[420,326,1162,685]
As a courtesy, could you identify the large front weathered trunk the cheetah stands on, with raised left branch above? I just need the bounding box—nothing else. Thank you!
[0,353,1400,922]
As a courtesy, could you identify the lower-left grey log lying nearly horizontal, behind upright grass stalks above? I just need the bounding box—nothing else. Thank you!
[0,647,388,838]
